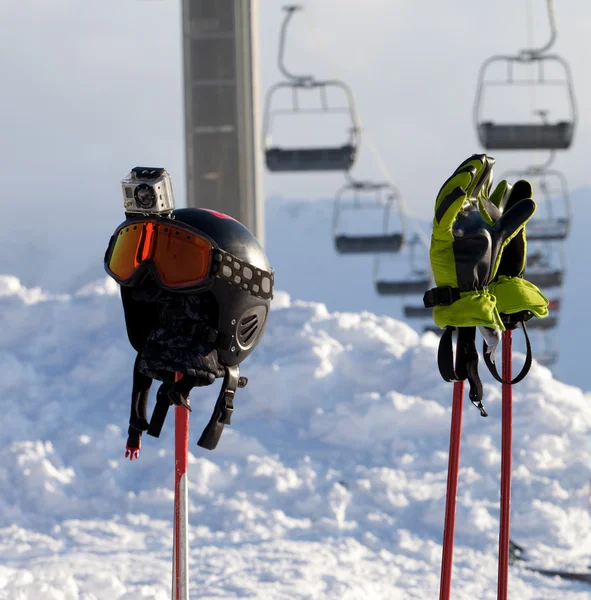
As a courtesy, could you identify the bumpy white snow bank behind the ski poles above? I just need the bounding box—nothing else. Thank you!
[0,272,591,600]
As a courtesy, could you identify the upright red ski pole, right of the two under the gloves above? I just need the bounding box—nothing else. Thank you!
[497,330,513,600]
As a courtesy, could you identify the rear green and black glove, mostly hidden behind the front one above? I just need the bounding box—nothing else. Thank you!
[483,180,548,323]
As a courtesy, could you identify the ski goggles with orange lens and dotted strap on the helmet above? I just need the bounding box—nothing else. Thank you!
[105,219,274,298]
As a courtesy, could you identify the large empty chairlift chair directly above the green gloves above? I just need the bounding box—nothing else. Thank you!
[473,0,577,150]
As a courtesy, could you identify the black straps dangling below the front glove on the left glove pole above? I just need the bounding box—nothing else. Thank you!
[440,328,488,417]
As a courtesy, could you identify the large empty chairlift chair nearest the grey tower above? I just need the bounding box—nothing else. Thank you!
[263,6,360,173]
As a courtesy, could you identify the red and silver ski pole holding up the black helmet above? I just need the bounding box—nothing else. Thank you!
[172,373,189,600]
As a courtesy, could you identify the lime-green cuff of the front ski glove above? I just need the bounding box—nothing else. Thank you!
[433,289,505,331]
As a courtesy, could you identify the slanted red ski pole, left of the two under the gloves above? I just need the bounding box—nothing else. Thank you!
[439,381,464,600]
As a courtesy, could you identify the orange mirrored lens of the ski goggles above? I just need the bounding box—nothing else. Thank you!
[109,223,212,287]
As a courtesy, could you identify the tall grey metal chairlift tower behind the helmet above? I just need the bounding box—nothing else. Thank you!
[182,0,264,244]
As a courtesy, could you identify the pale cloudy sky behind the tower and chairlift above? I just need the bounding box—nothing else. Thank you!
[0,0,591,286]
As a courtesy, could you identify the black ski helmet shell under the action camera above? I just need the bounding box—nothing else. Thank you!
[121,208,274,367]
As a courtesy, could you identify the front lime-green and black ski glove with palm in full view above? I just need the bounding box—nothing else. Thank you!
[423,154,536,330]
